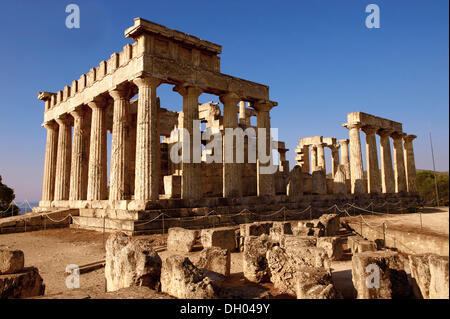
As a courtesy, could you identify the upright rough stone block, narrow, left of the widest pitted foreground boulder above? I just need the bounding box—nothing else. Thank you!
[242,234,272,283]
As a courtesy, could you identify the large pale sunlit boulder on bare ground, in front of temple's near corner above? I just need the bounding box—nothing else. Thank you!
[105,233,161,291]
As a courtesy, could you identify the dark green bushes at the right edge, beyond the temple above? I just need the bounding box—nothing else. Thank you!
[416,170,449,206]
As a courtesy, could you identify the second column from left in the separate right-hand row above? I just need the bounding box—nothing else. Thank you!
[362,126,381,194]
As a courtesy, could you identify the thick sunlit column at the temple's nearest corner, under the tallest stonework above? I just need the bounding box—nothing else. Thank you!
[134,77,161,201]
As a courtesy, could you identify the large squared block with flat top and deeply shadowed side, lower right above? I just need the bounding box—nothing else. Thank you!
[352,251,412,299]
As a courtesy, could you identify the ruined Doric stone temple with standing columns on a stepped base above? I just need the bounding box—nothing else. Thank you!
[35,18,418,234]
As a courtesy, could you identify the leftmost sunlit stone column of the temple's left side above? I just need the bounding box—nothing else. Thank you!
[42,121,58,201]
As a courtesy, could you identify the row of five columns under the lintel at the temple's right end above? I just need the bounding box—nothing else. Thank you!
[345,124,417,193]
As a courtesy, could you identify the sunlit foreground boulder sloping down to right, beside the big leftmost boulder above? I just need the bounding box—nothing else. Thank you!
[161,255,216,299]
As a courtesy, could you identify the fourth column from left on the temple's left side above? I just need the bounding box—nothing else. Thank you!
[87,97,108,200]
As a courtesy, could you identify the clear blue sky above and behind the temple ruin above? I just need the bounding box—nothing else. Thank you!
[0,0,449,200]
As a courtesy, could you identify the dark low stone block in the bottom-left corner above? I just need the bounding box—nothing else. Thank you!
[0,267,45,299]
